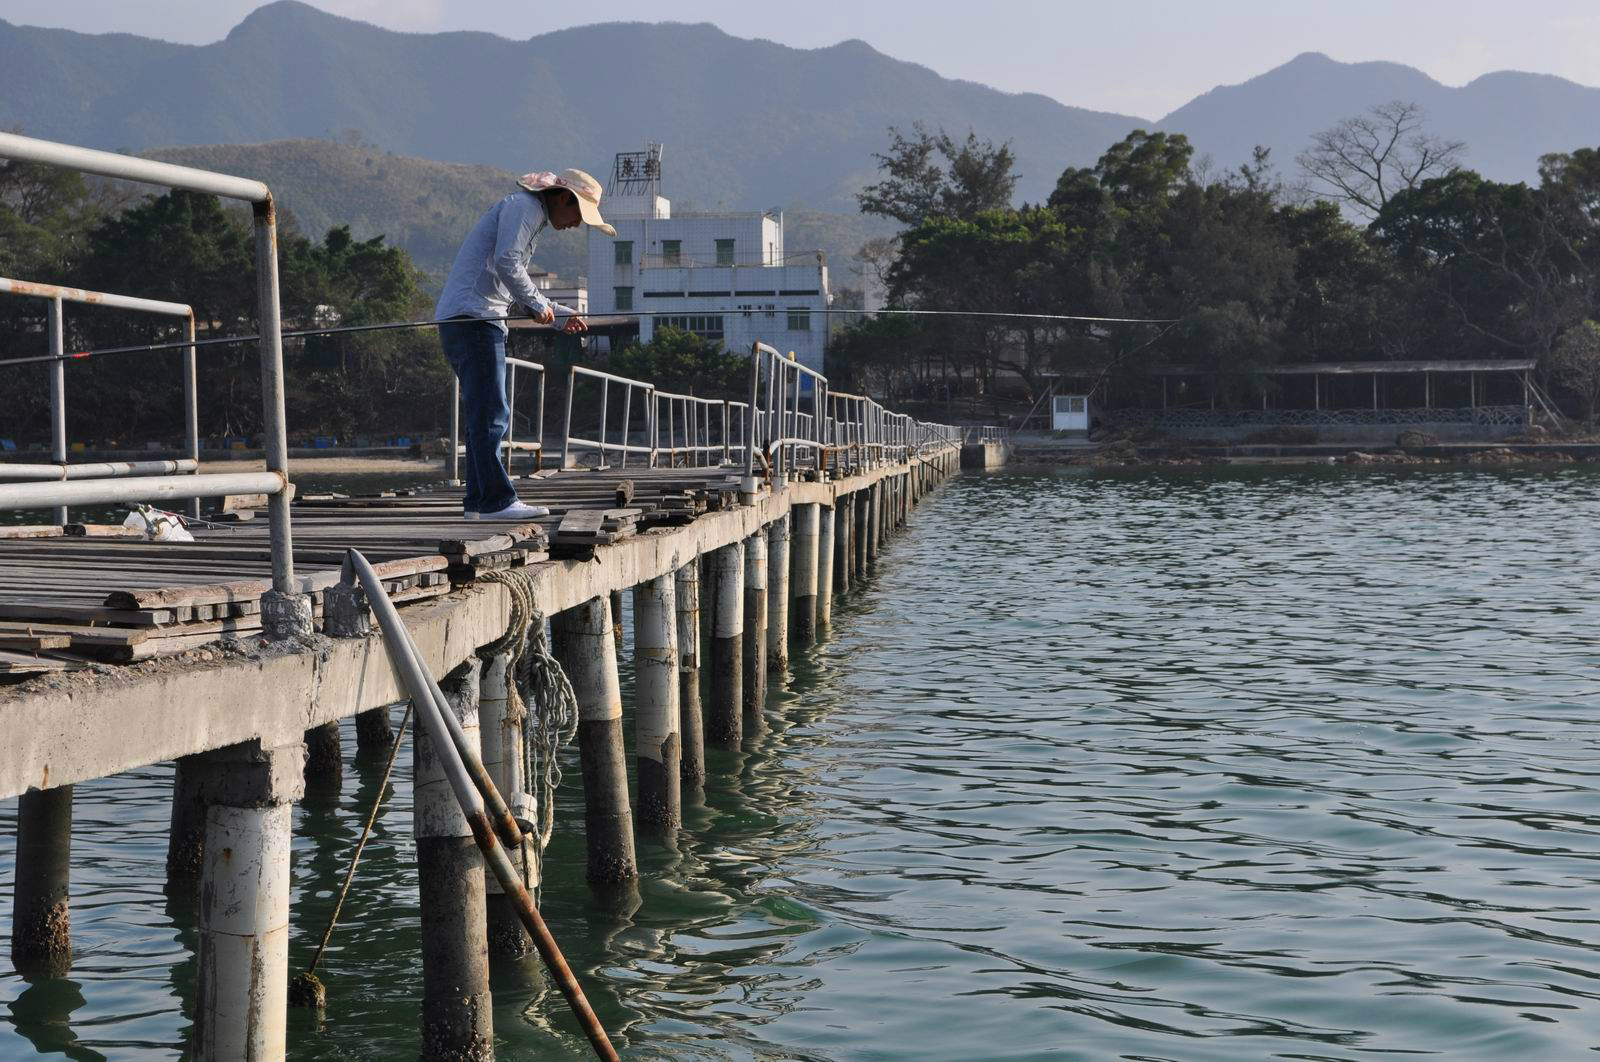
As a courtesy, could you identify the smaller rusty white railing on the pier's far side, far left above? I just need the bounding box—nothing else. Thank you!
[0,277,200,525]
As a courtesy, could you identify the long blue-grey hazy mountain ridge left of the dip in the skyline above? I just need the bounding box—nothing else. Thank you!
[0,0,1138,210]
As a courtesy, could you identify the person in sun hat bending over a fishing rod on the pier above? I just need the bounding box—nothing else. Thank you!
[434,170,616,520]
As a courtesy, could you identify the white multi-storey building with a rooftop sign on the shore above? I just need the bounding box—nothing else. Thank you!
[589,144,830,371]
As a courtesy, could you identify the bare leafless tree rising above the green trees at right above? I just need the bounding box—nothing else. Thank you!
[1298,99,1467,221]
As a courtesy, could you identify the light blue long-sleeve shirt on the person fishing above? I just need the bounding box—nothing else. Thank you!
[434,190,576,331]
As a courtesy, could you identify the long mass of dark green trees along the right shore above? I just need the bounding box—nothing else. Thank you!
[830,114,1600,417]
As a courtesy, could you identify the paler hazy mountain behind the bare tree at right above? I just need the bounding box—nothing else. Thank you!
[1157,53,1600,181]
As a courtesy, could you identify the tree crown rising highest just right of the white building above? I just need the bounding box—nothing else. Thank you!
[856,122,1019,226]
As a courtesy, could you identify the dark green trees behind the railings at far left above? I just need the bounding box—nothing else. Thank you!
[0,163,450,446]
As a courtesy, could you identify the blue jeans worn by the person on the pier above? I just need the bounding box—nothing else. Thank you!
[438,317,517,512]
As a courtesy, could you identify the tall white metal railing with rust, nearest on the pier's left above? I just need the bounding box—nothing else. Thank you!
[0,133,296,593]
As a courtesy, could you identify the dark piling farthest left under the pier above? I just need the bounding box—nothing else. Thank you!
[11,785,72,977]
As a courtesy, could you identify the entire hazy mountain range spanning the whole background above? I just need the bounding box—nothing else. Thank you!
[0,0,1600,279]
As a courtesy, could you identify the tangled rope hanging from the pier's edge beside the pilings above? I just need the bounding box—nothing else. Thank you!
[478,568,578,900]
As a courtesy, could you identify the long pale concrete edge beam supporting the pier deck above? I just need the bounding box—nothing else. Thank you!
[0,465,947,798]
